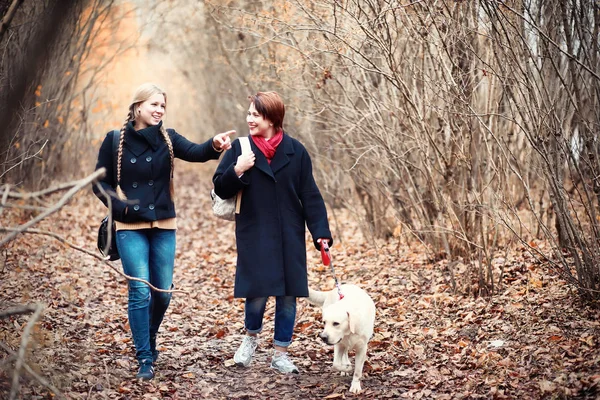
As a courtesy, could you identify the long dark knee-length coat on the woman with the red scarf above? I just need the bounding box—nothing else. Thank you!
[213,134,331,298]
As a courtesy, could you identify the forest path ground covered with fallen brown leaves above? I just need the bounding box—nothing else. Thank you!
[0,164,600,400]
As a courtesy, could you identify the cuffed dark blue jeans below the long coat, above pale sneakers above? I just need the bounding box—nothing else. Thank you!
[245,296,296,347]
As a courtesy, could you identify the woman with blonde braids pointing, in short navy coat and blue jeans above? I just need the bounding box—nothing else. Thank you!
[94,83,235,380]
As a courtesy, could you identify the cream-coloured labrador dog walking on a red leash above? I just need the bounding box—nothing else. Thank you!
[308,284,375,393]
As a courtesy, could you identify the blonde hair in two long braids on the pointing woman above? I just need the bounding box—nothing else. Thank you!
[117,83,175,200]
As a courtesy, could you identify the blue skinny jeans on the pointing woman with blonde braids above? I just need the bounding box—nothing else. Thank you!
[117,228,175,362]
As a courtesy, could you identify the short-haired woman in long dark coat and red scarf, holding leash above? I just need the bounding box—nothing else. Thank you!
[213,92,333,373]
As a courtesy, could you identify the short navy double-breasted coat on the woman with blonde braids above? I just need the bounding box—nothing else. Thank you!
[94,122,221,222]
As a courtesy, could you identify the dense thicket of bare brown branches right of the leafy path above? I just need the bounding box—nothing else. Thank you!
[195,0,600,293]
